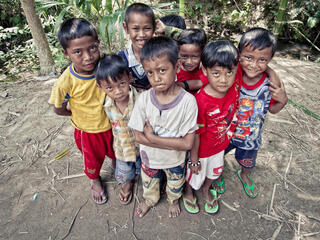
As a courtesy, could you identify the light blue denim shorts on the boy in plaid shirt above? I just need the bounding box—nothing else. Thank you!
[115,156,141,184]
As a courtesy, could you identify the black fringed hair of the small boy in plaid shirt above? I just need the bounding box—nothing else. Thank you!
[95,54,129,86]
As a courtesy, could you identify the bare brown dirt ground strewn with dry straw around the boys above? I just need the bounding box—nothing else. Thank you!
[0,57,320,240]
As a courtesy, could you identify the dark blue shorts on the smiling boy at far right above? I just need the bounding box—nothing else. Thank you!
[224,143,258,169]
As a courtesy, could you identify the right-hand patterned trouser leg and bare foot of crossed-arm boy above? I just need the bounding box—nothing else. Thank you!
[164,163,185,218]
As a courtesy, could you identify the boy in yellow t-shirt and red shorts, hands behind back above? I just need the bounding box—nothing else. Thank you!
[49,18,115,204]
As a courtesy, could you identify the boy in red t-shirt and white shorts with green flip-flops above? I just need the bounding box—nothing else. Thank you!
[182,40,240,214]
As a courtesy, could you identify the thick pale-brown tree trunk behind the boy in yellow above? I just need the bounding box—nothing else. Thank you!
[20,0,55,75]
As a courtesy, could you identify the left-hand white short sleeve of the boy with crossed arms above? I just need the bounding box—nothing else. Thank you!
[128,91,149,132]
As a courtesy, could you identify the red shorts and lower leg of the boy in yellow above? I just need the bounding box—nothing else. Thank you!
[74,129,114,204]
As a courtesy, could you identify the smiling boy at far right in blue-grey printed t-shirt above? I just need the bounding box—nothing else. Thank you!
[226,28,288,198]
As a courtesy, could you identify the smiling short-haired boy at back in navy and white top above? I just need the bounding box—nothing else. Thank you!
[118,3,156,91]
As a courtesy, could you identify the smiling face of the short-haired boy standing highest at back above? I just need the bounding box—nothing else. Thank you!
[123,12,154,53]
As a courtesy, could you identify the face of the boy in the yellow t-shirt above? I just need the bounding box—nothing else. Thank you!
[62,36,100,75]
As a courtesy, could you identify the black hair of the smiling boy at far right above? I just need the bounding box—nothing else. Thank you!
[238,28,277,57]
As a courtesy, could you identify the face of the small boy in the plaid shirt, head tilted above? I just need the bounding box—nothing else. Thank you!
[97,73,130,103]
